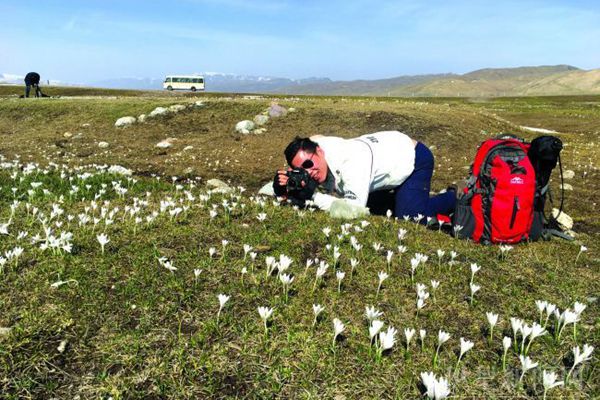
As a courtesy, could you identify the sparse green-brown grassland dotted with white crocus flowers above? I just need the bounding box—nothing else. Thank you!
[0,88,600,399]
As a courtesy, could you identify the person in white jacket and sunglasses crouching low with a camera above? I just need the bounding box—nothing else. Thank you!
[273,131,456,222]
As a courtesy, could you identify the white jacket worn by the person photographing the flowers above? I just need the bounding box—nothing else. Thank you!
[311,131,415,210]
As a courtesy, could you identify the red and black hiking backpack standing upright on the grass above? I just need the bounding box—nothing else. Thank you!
[452,137,544,244]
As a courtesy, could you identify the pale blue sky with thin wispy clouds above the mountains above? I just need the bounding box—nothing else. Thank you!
[0,0,600,83]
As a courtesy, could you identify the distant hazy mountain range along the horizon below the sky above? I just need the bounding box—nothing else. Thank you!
[0,65,600,97]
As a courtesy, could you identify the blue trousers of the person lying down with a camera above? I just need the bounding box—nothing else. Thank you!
[394,142,456,222]
